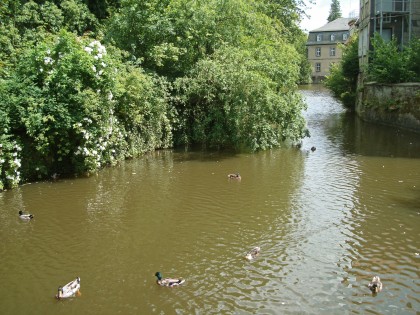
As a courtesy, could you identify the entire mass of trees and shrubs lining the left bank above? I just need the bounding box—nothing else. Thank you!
[0,0,307,189]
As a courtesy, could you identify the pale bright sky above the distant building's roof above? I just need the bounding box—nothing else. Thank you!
[300,0,359,33]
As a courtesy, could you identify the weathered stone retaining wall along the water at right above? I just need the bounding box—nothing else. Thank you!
[356,83,420,133]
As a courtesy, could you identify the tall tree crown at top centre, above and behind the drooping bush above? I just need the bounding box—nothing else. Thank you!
[105,0,302,79]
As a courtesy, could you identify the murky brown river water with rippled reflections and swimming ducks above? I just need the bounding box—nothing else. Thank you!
[0,87,420,314]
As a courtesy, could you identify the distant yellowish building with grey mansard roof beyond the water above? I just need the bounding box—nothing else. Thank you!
[306,17,354,83]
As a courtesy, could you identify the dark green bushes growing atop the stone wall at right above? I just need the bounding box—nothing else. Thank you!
[367,34,420,83]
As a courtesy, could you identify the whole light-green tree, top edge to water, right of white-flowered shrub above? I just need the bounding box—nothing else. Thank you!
[105,0,306,150]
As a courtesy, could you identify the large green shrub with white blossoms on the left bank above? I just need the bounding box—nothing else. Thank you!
[0,31,172,189]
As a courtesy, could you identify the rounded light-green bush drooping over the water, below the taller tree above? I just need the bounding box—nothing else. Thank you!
[175,46,307,150]
